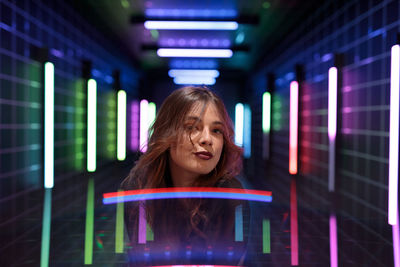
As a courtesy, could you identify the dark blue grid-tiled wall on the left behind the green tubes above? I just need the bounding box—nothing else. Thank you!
[0,0,137,265]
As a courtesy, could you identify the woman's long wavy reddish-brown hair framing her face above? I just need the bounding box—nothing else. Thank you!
[122,86,242,241]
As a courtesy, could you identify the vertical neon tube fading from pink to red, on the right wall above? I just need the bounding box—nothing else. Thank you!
[289,81,299,174]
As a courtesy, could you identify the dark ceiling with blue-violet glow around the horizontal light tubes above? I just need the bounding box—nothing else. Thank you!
[71,0,324,75]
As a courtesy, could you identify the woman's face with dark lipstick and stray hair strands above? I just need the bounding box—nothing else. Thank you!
[170,104,224,182]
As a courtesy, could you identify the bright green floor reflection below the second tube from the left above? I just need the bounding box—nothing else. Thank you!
[84,178,94,264]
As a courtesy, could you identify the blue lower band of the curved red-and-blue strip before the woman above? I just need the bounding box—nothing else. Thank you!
[103,192,272,204]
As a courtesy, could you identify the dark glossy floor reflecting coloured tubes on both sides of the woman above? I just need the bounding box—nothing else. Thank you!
[2,158,393,266]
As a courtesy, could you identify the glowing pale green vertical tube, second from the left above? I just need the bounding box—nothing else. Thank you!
[87,79,97,172]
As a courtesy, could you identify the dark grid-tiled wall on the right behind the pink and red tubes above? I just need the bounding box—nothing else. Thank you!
[250,0,400,266]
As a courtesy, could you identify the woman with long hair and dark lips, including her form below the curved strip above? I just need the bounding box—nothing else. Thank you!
[122,87,247,265]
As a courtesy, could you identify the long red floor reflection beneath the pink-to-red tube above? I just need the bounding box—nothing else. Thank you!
[290,178,299,266]
